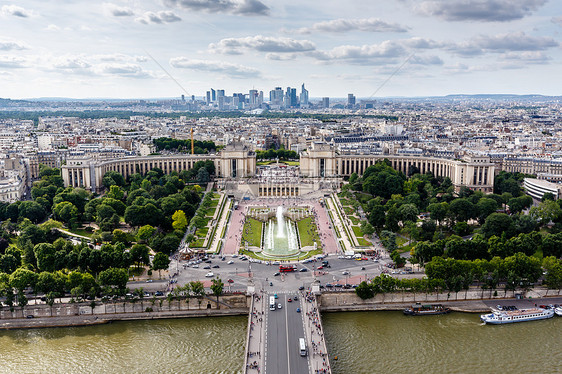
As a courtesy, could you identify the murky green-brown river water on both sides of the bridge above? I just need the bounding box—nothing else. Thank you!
[0,312,562,374]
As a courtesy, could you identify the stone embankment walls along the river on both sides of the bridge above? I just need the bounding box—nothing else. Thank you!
[0,290,562,330]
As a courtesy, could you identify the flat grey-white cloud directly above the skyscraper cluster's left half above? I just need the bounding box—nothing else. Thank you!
[209,35,316,55]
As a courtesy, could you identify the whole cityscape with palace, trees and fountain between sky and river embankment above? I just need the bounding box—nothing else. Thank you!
[0,92,562,317]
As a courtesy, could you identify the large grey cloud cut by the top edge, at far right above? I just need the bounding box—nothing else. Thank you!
[414,0,547,22]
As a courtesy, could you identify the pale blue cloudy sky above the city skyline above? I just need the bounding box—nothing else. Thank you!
[0,0,562,99]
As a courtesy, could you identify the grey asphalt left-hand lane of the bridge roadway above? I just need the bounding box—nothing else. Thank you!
[265,293,289,374]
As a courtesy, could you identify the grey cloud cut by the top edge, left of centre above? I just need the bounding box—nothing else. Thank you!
[164,0,269,16]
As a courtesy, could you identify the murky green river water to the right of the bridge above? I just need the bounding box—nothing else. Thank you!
[322,312,562,374]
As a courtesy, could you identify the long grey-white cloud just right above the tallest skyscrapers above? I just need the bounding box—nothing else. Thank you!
[307,40,406,64]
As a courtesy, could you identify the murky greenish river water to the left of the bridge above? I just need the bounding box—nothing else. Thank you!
[0,316,248,374]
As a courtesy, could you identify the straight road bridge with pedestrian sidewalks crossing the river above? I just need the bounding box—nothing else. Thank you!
[244,291,331,374]
